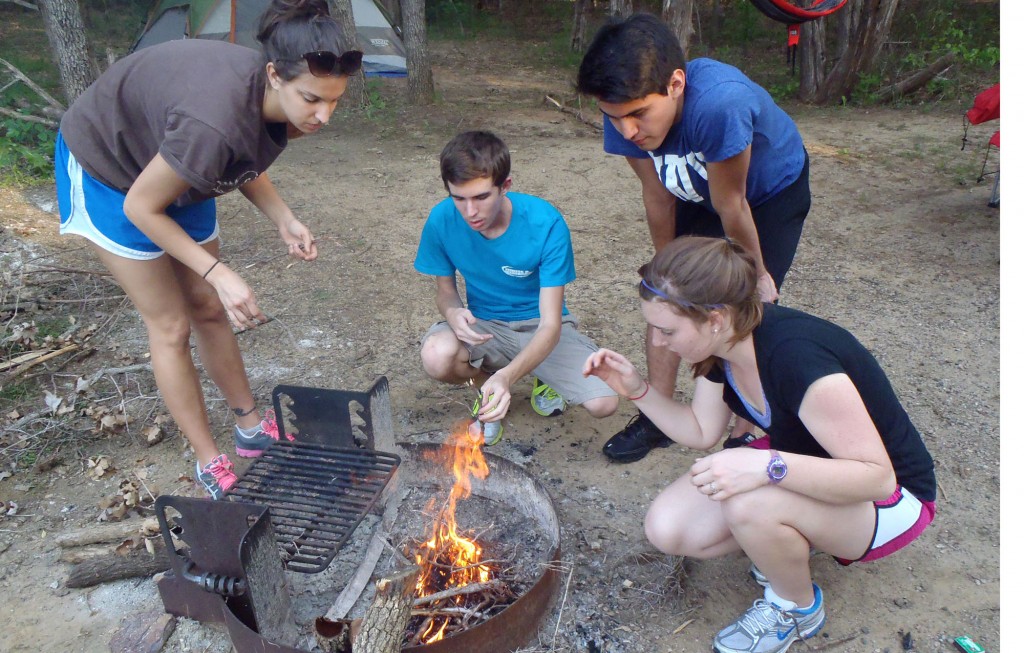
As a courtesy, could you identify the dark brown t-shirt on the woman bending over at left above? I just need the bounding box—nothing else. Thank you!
[60,39,288,206]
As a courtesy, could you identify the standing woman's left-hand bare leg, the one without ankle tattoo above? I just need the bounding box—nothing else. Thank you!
[90,244,220,467]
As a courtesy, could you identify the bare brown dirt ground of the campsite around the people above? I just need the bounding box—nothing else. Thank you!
[0,43,1009,653]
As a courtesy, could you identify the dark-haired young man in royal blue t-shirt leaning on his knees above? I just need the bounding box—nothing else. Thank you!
[577,13,811,463]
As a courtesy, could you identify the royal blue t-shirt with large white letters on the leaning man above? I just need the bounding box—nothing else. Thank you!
[604,58,806,211]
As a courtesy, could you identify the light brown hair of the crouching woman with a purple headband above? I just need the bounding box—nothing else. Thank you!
[640,236,763,377]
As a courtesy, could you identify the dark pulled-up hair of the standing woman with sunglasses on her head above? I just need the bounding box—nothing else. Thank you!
[256,0,350,82]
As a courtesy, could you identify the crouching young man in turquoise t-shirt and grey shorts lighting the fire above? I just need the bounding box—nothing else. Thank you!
[415,131,618,444]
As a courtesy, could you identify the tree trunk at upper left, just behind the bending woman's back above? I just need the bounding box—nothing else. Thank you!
[39,0,99,105]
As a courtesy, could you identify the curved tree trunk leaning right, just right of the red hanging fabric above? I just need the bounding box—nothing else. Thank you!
[811,0,899,104]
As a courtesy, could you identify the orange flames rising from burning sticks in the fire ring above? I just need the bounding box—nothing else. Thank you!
[416,422,490,644]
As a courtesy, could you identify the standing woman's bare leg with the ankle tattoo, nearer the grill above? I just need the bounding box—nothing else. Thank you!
[171,242,262,429]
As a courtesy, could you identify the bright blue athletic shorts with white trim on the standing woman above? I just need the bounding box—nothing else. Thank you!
[53,132,220,261]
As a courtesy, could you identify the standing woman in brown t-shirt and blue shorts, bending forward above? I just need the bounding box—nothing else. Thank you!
[55,0,361,498]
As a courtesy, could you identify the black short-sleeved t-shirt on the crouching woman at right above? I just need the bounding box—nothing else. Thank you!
[707,304,936,502]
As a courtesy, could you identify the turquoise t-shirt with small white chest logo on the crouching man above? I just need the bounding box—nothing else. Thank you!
[414,192,575,321]
